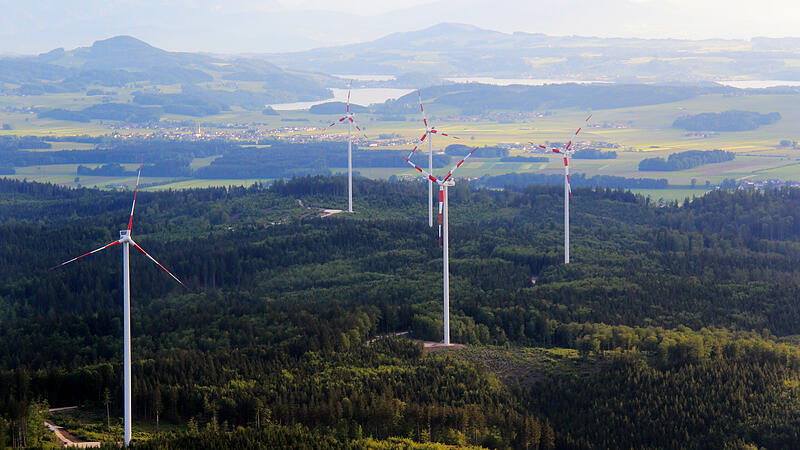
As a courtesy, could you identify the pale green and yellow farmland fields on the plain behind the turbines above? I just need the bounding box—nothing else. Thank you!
[0,86,800,199]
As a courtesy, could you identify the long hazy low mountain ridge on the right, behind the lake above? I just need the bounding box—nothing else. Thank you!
[264,23,800,82]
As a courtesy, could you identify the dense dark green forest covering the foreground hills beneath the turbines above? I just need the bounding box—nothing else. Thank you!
[0,177,800,449]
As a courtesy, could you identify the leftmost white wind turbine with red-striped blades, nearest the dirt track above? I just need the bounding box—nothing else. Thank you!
[52,164,188,447]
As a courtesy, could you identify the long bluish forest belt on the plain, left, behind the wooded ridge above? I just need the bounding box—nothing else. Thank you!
[0,136,450,179]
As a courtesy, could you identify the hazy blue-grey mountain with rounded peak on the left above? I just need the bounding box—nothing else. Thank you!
[0,36,332,109]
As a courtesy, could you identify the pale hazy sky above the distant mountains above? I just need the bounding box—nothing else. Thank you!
[0,0,800,54]
